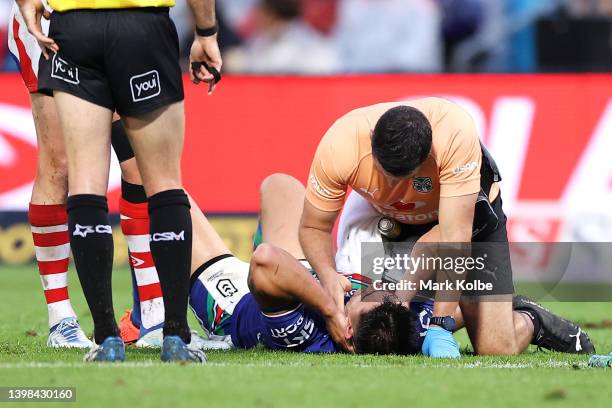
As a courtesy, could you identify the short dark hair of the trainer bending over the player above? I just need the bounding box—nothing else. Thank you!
[372,106,432,177]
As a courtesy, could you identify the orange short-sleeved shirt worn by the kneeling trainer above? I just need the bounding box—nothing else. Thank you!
[306,98,482,224]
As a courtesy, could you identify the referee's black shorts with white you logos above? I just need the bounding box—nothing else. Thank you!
[39,8,184,116]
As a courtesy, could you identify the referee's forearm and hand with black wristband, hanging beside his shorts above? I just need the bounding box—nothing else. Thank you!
[188,0,223,94]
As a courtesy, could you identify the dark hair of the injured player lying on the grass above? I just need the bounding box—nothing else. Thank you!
[353,296,420,355]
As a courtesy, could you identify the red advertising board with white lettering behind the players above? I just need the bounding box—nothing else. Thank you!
[0,75,612,239]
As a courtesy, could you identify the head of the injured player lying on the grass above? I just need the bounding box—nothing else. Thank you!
[346,291,420,355]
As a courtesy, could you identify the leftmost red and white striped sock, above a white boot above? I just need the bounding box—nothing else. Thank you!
[28,204,76,327]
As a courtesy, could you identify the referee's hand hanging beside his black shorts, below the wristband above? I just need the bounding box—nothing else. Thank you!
[189,34,223,95]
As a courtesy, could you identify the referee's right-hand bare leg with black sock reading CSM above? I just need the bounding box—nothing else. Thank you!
[122,102,192,343]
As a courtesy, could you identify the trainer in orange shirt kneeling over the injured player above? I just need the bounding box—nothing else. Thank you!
[300,98,531,357]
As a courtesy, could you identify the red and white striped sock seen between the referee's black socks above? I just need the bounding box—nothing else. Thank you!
[119,198,164,330]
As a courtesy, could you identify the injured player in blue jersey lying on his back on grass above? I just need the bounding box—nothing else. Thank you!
[118,174,594,355]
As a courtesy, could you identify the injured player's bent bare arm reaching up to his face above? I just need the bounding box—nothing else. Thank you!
[249,243,353,352]
